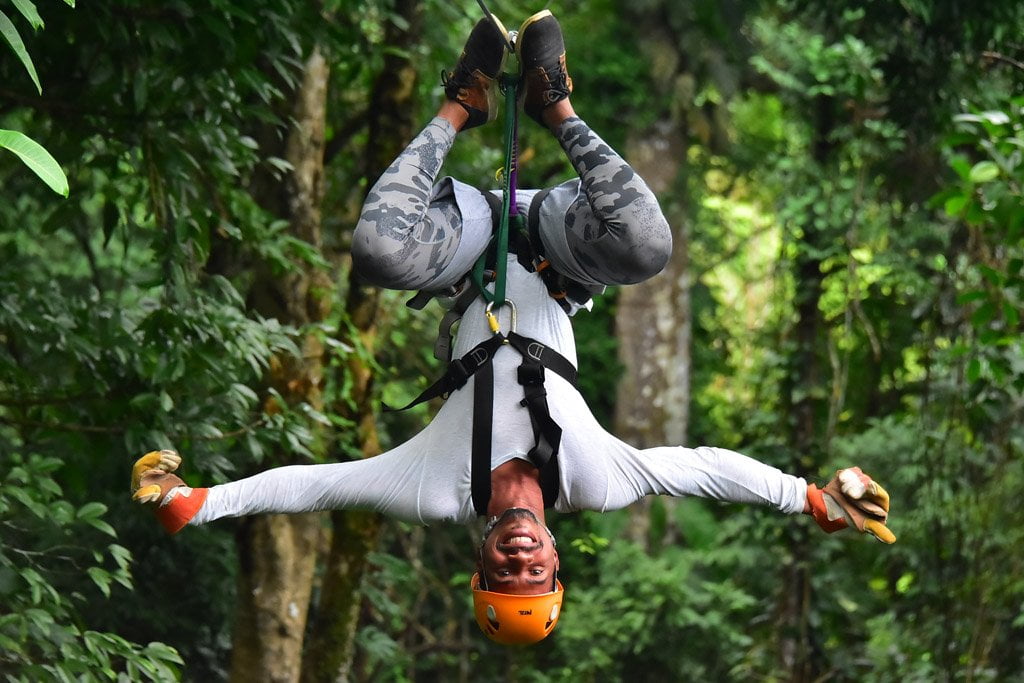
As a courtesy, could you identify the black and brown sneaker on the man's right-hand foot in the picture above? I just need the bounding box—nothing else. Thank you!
[515,9,572,126]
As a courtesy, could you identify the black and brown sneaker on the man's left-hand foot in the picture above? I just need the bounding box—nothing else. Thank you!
[441,17,509,130]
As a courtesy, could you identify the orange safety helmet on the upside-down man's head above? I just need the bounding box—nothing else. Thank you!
[470,572,564,645]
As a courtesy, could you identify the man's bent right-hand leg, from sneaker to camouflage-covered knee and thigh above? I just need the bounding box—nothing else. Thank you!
[517,10,672,285]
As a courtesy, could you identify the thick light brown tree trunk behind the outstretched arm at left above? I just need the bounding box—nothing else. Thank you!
[231,49,332,683]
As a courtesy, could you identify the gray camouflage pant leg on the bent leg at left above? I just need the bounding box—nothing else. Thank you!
[352,118,464,290]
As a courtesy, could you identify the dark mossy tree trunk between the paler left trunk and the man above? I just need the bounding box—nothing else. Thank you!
[302,0,423,683]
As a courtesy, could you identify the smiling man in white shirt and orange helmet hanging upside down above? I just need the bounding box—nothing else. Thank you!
[132,10,895,644]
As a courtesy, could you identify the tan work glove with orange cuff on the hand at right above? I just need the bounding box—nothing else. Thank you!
[807,467,896,543]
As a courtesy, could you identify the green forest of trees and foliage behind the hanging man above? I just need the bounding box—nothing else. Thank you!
[0,0,1024,681]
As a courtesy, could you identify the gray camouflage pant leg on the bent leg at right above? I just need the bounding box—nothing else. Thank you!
[540,118,672,285]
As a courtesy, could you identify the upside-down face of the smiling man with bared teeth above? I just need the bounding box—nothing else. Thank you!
[479,508,558,595]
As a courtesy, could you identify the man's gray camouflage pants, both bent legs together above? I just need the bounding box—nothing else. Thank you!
[352,118,672,291]
